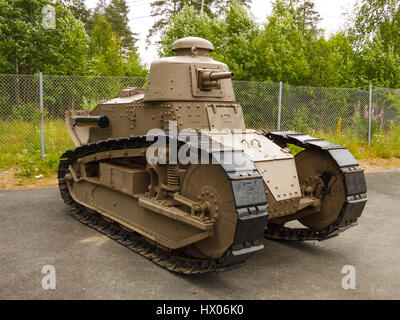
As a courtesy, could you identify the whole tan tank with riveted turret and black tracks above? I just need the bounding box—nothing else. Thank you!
[58,37,367,274]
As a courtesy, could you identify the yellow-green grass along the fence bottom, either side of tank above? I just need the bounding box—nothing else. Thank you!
[0,119,400,179]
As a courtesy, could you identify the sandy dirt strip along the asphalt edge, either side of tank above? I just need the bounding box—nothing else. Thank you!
[0,158,400,190]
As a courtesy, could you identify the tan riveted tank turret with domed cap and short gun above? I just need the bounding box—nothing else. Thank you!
[144,37,235,102]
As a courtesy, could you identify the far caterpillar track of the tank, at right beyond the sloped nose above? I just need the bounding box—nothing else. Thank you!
[265,131,368,241]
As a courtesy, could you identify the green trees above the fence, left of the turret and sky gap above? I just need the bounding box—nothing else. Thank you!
[0,0,146,76]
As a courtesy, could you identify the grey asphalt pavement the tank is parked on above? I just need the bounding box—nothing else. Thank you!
[0,172,400,299]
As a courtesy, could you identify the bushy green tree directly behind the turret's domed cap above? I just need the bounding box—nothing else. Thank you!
[159,1,259,80]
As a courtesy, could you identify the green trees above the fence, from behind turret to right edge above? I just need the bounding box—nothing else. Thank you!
[154,0,400,88]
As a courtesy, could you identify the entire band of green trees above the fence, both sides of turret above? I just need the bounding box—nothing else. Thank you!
[0,0,400,88]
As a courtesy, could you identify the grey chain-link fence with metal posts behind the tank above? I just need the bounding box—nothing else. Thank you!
[0,75,400,160]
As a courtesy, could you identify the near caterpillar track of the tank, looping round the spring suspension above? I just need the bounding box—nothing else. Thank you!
[58,136,267,275]
